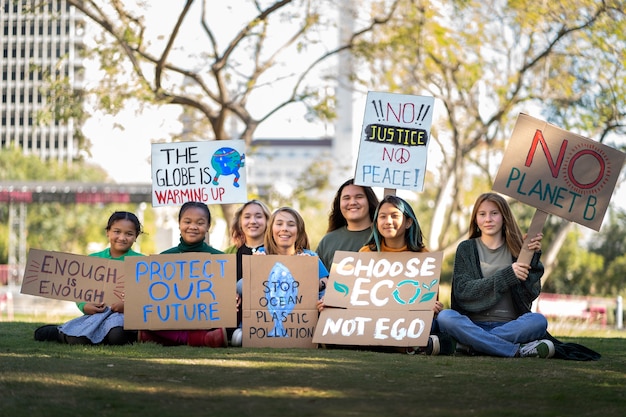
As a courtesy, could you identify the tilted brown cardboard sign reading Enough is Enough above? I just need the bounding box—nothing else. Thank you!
[20,249,125,305]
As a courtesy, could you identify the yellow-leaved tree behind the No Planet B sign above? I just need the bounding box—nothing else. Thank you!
[357,0,626,274]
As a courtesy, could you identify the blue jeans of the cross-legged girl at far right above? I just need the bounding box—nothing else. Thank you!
[437,309,548,357]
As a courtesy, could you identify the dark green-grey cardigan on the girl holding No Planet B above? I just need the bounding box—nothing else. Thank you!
[451,239,543,316]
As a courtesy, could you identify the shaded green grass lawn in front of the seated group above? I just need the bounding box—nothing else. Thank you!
[0,321,626,417]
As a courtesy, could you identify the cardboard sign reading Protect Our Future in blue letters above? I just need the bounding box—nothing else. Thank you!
[124,252,237,330]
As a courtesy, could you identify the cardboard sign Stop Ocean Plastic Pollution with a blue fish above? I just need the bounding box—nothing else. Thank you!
[242,255,319,348]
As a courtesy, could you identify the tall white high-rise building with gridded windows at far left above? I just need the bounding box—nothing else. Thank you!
[0,0,84,162]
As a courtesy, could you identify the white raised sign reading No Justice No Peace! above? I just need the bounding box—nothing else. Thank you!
[354,91,435,191]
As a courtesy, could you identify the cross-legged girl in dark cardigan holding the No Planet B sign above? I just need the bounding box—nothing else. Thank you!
[437,193,554,358]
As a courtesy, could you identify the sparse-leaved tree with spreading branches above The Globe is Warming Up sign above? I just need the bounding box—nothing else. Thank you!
[58,0,397,224]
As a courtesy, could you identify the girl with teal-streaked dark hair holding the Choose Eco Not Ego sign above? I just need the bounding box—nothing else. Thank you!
[317,195,444,354]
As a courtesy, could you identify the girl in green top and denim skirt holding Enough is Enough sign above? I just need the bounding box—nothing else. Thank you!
[35,211,142,345]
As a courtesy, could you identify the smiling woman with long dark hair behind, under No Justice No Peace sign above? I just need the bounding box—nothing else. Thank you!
[316,179,378,271]
